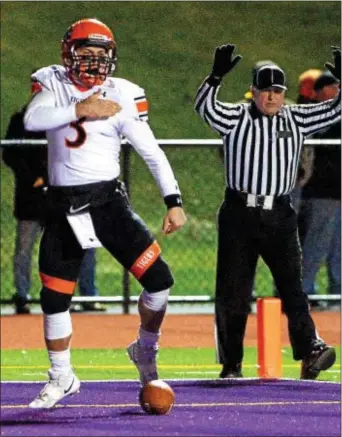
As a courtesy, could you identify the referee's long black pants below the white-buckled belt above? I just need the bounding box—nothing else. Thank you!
[215,189,317,368]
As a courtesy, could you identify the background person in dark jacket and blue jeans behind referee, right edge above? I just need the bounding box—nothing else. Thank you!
[299,72,341,307]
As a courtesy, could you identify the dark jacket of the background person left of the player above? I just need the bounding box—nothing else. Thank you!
[2,106,48,221]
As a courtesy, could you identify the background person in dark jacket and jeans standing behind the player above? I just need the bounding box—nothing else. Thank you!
[2,96,106,314]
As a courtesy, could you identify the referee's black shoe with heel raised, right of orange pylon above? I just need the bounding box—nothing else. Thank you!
[300,340,336,379]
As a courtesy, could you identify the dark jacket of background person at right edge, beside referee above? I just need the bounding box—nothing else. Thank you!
[302,123,341,200]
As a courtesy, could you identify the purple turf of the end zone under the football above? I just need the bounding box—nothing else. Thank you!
[0,379,341,437]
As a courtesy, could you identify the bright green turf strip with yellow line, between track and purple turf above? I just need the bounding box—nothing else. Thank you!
[1,347,341,382]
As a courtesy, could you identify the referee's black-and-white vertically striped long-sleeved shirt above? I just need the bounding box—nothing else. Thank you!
[195,78,341,196]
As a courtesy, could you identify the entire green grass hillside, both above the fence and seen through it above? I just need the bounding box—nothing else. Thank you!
[0,1,341,298]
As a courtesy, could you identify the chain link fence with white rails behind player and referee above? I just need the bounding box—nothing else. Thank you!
[1,140,340,312]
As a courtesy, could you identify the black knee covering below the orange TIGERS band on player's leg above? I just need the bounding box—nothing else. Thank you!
[139,257,174,293]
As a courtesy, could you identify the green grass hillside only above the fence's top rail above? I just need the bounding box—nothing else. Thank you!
[1,1,341,138]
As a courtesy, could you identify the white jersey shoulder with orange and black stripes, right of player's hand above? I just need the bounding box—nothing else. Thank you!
[113,78,148,121]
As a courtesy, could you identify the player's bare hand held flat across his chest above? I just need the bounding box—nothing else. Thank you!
[76,90,121,120]
